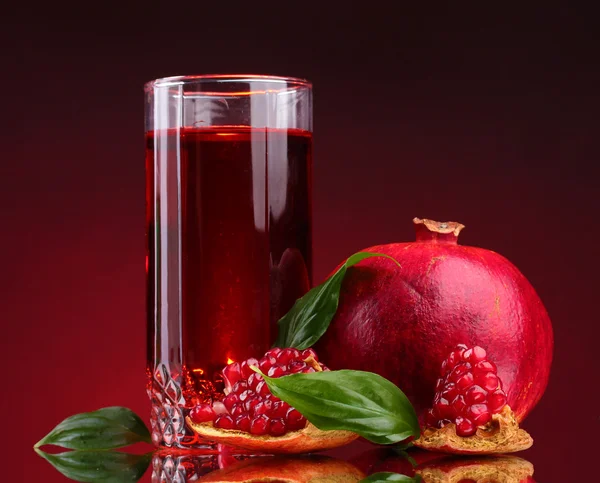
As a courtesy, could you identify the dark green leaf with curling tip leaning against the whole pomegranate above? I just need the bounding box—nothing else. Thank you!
[274,252,400,349]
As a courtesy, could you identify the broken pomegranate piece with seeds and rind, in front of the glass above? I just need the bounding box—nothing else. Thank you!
[188,348,357,453]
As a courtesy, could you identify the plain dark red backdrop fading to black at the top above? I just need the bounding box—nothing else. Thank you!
[0,2,600,482]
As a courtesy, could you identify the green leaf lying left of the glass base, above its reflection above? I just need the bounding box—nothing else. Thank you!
[35,406,152,451]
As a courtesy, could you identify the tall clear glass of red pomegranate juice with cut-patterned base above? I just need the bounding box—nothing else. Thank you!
[145,75,312,448]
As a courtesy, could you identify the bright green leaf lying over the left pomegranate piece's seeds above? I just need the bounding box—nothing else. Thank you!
[253,368,420,444]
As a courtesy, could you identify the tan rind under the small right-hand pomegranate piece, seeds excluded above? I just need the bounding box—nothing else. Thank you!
[414,405,533,454]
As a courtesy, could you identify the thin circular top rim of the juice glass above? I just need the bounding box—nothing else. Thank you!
[144,74,312,92]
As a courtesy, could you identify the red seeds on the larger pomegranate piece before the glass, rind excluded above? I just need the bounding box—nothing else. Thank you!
[190,348,328,436]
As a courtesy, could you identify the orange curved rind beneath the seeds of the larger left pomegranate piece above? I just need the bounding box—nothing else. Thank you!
[186,417,358,454]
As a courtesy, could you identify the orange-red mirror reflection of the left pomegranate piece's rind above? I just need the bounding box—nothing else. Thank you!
[198,456,365,483]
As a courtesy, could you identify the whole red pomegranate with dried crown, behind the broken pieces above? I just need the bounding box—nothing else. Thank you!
[317,218,553,422]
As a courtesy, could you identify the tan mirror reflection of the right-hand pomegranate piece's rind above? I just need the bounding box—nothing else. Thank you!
[416,456,533,483]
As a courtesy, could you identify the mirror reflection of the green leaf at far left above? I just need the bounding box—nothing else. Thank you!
[36,448,152,483]
